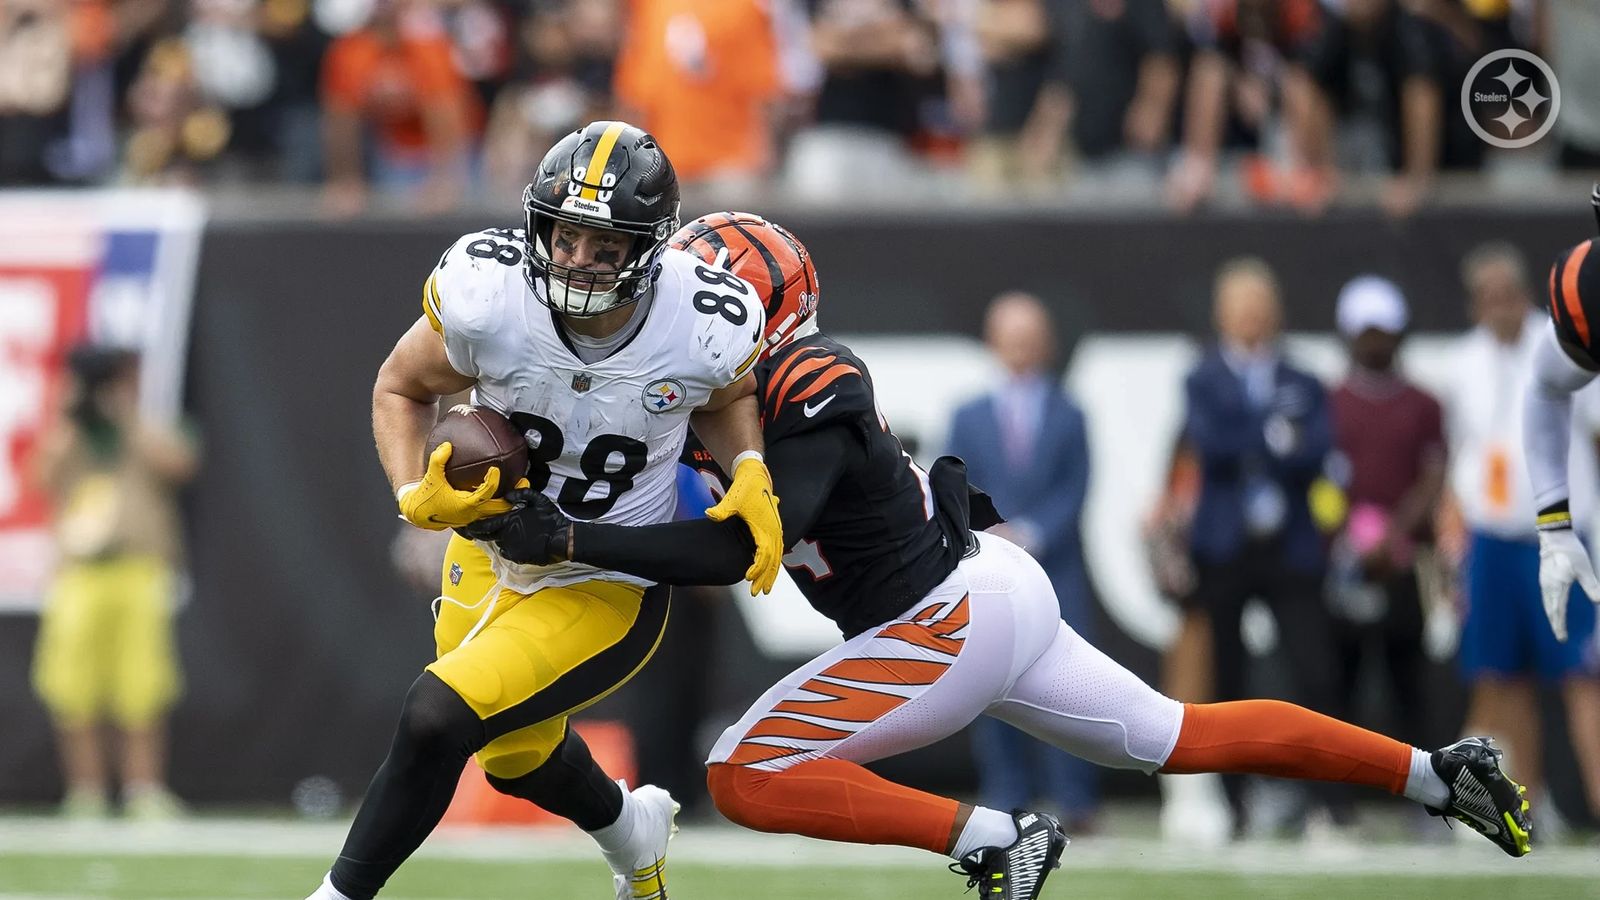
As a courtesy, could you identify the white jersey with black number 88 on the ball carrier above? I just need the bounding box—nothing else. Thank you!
[422,229,765,593]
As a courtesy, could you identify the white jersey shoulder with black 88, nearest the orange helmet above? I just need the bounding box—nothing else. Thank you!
[656,248,766,388]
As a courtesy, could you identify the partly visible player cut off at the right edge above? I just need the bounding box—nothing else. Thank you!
[1522,184,1600,640]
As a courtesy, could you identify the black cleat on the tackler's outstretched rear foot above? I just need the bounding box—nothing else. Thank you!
[1427,738,1533,857]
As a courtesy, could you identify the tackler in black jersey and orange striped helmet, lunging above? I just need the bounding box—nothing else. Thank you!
[467,213,1530,900]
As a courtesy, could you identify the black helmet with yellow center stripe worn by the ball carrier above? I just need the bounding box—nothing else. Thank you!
[522,122,678,317]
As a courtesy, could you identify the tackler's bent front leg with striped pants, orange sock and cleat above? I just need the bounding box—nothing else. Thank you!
[707,531,1066,900]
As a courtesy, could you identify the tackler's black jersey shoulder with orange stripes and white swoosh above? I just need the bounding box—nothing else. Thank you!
[757,343,877,444]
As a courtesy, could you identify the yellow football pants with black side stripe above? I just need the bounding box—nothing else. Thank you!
[427,535,669,778]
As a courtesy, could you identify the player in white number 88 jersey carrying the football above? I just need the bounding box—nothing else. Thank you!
[312,122,782,900]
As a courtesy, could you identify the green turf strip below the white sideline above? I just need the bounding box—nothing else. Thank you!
[0,855,1580,900]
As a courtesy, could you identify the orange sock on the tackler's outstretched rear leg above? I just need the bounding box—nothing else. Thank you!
[1162,700,1411,794]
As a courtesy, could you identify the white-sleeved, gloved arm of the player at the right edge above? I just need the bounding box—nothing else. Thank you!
[1522,318,1600,641]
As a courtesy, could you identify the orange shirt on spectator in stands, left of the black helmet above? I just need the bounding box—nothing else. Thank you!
[322,29,483,151]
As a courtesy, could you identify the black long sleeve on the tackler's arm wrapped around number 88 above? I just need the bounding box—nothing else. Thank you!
[573,424,862,585]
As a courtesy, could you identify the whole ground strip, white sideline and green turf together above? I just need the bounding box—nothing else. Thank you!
[0,817,1600,900]
